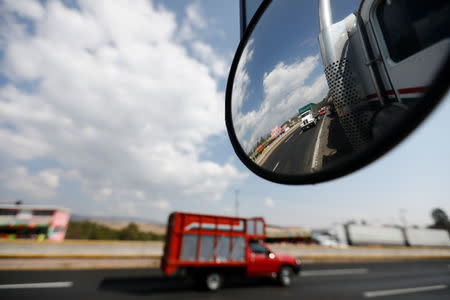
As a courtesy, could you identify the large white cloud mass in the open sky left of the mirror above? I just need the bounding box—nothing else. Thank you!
[0,0,246,218]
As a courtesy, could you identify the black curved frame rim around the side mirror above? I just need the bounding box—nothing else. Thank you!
[225,0,450,185]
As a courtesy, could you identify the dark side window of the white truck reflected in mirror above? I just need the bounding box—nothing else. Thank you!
[377,0,450,62]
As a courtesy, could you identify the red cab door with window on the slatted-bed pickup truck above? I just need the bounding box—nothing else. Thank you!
[247,240,278,276]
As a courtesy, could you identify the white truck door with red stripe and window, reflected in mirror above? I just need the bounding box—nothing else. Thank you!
[369,0,450,104]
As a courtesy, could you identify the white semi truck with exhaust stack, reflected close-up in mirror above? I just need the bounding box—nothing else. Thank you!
[319,0,450,150]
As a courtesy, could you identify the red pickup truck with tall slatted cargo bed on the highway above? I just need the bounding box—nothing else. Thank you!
[161,212,300,290]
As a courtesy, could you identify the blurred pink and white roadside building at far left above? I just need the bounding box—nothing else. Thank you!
[0,204,70,241]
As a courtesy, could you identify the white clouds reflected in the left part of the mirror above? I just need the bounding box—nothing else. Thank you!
[233,43,328,152]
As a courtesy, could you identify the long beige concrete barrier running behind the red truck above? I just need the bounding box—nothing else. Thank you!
[0,241,450,270]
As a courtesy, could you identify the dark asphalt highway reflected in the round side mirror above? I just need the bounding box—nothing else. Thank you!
[262,115,352,175]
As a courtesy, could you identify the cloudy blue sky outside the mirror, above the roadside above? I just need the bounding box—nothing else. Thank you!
[0,0,450,227]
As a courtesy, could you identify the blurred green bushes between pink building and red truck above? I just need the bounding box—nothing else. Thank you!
[66,221,164,241]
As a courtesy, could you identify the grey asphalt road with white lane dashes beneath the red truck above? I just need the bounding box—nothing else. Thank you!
[0,260,450,300]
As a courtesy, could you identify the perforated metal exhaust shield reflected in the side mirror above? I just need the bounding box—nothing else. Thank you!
[325,58,373,150]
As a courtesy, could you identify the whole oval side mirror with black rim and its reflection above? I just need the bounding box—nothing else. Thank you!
[225,0,450,184]
